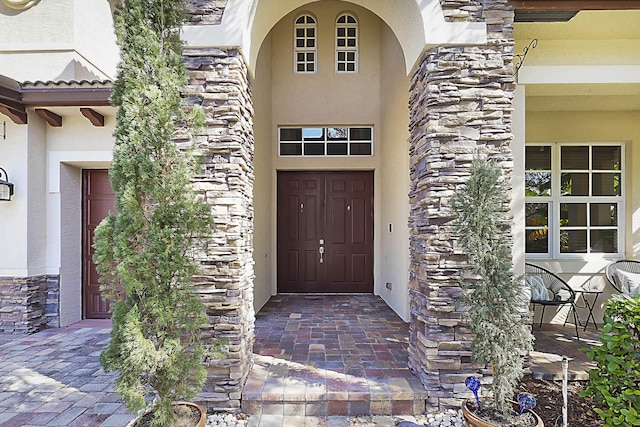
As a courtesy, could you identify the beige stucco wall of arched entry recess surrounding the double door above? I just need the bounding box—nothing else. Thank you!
[252,1,409,320]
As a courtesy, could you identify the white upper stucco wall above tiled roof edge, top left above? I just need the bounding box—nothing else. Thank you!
[0,0,118,82]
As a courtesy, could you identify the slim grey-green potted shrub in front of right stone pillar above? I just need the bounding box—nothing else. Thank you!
[451,155,541,426]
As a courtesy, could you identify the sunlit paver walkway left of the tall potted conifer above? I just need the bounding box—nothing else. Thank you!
[0,321,133,427]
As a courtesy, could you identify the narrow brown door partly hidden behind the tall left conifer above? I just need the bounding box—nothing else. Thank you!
[82,170,116,319]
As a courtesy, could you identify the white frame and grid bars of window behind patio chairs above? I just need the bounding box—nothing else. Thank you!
[525,142,626,259]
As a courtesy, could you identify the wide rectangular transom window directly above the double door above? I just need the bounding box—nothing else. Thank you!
[278,126,373,156]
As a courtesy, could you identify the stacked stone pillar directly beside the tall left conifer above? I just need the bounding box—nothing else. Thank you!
[184,49,254,410]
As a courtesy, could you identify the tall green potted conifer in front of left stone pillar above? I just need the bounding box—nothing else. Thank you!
[94,0,212,426]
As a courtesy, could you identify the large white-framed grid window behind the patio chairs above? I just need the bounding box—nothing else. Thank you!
[525,143,624,258]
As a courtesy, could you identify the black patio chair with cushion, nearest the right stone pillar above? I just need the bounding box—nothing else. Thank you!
[524,263,580,339]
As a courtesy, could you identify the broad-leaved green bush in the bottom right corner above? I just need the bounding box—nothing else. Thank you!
[581,295,640,426]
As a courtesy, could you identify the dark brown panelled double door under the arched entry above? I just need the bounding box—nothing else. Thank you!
[277,172,373,293]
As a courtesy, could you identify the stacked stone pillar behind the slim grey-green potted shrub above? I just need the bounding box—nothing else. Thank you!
[409,0,515,409]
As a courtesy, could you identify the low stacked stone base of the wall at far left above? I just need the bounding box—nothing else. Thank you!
[0,275,60,334]
